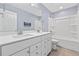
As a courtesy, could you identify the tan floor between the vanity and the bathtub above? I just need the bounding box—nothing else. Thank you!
[49,47,79,56]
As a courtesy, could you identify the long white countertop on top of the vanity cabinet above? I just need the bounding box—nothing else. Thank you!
[0,32,50,46]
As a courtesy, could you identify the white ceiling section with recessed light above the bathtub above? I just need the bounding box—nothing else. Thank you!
[43,3,77,12]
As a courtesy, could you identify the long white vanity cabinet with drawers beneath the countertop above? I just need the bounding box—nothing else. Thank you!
[0,33,51,56]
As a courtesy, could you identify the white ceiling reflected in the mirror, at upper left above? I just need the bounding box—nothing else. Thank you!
[10,3,41,16]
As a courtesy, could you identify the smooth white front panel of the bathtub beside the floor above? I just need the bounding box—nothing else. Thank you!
[58,40,79,52]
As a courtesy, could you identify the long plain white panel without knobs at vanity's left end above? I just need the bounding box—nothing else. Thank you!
[2,40,31,56]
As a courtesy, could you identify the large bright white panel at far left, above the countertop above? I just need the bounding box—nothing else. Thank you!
[0,8,17,34]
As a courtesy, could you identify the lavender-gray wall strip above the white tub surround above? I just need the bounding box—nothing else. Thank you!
[52,6,77,18]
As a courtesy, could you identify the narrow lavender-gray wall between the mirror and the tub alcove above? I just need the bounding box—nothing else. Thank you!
[39,4,50,32]
